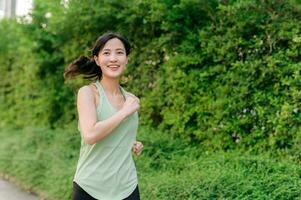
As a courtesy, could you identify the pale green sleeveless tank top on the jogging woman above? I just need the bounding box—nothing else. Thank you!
[74,81,138,200]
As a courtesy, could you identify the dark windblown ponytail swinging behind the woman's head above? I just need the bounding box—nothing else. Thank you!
[64,56,102,79]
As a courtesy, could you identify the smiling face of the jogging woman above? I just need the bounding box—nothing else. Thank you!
[94,38,128,78]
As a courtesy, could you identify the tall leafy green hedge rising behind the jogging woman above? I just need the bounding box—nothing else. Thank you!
[0,0,301,150]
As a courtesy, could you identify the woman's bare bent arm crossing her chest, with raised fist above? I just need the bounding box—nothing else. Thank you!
[77,86,140,144]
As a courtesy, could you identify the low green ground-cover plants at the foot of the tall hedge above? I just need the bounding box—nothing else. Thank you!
[0,125,301,200]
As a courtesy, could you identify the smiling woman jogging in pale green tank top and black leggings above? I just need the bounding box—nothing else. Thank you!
[64,33,143,200]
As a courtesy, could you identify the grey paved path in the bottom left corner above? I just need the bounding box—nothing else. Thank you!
[0,179,39,200]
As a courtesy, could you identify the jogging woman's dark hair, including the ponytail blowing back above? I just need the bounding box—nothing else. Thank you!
[64,32,131,80]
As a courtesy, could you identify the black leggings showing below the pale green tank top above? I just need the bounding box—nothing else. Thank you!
[72,182,140,200]
